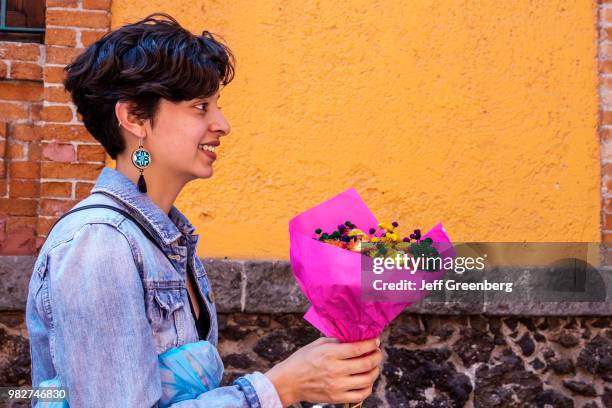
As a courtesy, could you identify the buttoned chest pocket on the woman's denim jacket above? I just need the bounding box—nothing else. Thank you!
[146,288,186,354]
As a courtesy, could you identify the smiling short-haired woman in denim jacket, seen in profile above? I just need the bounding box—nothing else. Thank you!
[26,14,382,408]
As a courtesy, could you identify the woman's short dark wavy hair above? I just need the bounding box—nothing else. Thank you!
[64,13,235,159]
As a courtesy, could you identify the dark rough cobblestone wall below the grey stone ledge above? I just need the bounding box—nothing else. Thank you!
[0,313,612,408]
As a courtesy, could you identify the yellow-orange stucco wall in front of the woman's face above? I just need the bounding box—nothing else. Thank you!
[112,0,600,259]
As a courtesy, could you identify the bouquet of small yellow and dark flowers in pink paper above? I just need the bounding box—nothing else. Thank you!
[289,188,450,407]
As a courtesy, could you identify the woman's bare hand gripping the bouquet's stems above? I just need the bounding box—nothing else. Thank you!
[265,337,383,407]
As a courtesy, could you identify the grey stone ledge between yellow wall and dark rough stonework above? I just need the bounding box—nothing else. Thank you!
[0,256,612,316]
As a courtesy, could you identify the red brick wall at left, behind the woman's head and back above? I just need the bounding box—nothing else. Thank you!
[0,0,111,255]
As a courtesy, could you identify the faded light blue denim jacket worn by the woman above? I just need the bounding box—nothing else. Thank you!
[26,167,282,408]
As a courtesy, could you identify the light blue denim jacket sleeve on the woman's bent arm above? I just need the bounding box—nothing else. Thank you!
[48,223,282,408]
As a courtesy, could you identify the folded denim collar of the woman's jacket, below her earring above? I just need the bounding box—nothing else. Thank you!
[91,167,197,245]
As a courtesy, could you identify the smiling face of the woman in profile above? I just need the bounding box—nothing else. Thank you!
[146,91,230,182]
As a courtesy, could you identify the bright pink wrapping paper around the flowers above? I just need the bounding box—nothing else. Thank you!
[289,188,450,342]
